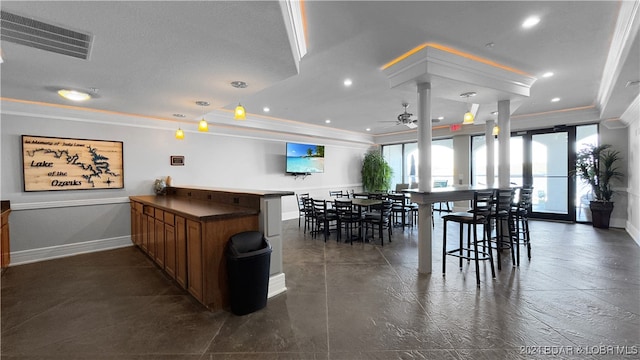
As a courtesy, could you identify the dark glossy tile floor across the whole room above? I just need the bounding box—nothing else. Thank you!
[0,220,640,360]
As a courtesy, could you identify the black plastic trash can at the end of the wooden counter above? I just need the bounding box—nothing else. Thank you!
[225,231,271,315]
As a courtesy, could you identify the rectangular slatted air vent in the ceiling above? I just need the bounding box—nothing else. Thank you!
[0,11,92,60]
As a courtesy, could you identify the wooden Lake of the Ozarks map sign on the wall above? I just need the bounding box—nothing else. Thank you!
[22,135,124,191]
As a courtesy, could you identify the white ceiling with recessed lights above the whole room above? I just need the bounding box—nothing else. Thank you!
[1,1,640,138]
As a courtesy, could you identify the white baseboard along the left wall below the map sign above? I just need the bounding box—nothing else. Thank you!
[9,235,133,266]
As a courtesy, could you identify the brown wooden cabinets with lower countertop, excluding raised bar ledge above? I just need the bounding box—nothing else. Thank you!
[131,196,259,310]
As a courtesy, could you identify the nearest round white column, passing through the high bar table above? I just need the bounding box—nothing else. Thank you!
[418,83,433,274]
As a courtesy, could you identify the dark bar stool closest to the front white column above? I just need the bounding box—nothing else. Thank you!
[442,190,496,287]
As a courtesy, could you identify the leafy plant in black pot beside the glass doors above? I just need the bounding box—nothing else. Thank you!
[575,144,624,229]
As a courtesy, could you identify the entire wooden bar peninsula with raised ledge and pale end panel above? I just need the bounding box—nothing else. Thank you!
[130,187,293,310]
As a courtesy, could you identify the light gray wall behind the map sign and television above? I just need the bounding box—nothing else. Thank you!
[0,106,368,263]
